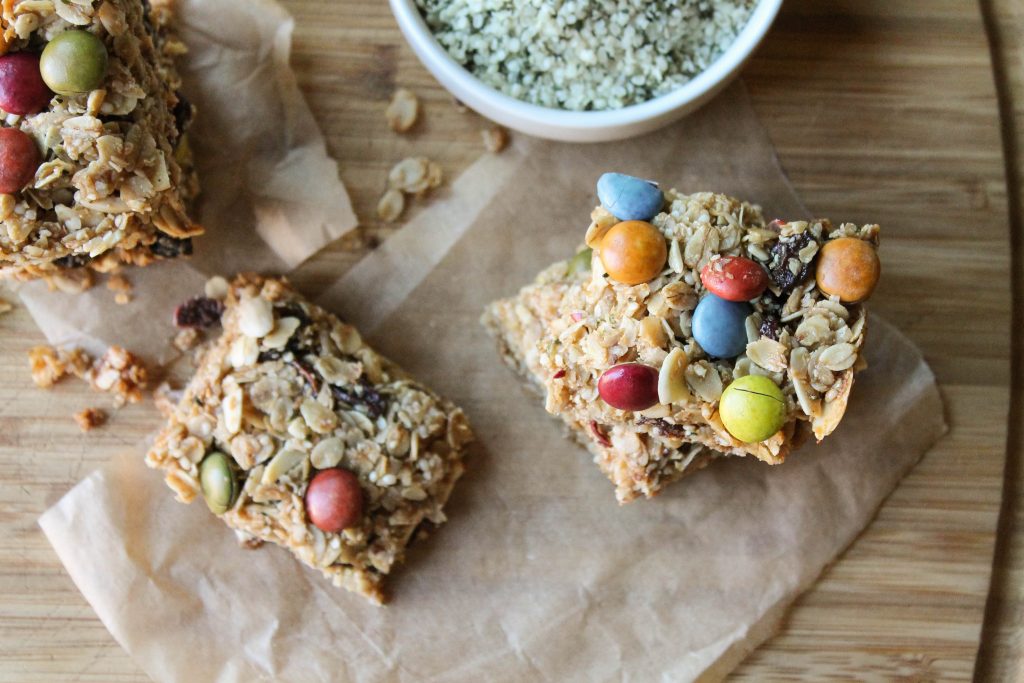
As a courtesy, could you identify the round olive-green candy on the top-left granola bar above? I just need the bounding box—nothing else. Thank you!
[39,30,108,95]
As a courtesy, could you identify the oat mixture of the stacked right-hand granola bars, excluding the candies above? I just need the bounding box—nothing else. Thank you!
[482,190,879,502]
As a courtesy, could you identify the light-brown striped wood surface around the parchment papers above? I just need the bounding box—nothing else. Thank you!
[0,0,1011,682]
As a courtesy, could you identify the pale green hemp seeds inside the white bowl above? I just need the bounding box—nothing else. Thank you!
[417,0,755,111]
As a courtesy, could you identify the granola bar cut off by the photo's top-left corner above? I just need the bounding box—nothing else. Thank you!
[0,0,202,280]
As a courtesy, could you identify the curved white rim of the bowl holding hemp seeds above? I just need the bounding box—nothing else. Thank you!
[390,0,782,130]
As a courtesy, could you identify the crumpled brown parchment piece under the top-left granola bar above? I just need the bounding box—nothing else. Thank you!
[19,0,356,362]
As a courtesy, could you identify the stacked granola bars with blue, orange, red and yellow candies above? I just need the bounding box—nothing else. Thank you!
[483,174,879,502]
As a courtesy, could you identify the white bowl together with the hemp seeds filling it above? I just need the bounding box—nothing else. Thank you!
[390,0,782,142]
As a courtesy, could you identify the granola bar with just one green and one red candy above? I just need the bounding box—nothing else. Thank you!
[146,276,472,603]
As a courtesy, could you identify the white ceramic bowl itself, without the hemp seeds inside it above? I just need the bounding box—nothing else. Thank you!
[390,0,782,142]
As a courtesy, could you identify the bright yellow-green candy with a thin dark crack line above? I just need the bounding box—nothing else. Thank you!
[718,375,785,443]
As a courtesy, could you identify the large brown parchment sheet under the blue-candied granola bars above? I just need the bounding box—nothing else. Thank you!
[40,82,944,683]
